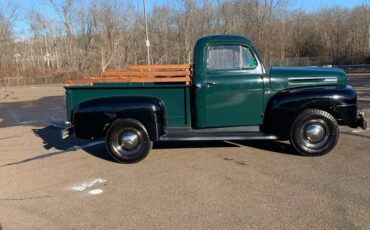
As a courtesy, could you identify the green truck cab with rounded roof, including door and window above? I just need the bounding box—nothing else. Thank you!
[194,35,269,128]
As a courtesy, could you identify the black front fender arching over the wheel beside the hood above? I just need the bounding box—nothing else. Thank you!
[264,86,357,137]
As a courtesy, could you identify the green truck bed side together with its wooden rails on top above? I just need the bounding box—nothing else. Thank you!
[65,64,191,127]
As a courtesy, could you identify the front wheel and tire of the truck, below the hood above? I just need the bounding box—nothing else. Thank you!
[290,109,339,156]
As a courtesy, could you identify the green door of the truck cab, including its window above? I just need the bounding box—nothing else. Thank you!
[202,44,264,127]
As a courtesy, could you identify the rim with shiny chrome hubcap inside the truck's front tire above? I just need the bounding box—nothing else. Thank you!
[299,119,330,151]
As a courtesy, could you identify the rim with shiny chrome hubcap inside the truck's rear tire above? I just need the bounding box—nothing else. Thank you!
[112,129,143,156]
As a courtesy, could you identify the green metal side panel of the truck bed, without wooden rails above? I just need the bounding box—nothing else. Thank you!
[65,82,191,127]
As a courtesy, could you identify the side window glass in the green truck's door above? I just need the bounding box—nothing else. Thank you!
[207,45,257,70]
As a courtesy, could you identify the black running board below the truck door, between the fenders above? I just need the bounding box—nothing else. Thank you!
[159,130,278,141]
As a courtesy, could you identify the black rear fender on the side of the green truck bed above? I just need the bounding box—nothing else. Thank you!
[72,97,165,141]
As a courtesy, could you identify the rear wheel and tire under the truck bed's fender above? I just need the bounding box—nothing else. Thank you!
[106,119,153,163]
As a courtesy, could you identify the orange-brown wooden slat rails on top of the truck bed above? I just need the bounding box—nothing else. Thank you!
[66,64,191,86]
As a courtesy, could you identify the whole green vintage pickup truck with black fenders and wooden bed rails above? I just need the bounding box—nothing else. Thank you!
[62,35,367,163]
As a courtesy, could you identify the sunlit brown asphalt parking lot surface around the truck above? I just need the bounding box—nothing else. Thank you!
[0,74,370,229]
